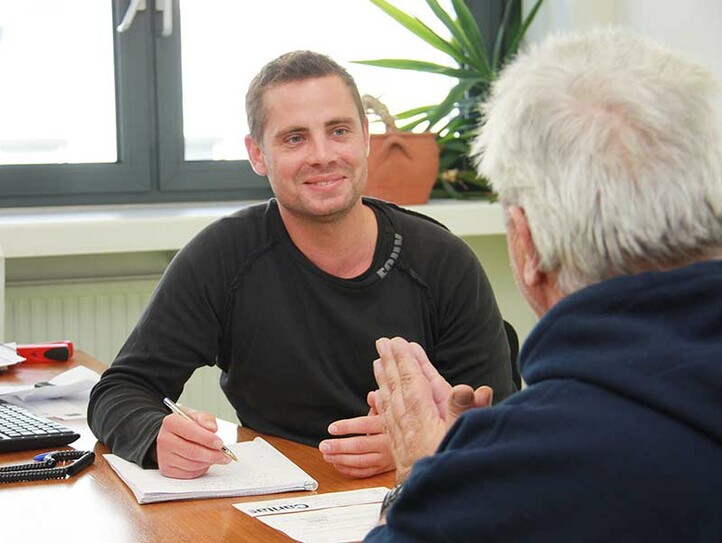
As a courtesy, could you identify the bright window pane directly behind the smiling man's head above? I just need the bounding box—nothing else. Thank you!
[181,0,455,160]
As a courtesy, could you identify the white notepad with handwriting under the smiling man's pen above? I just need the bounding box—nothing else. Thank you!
[103,437,318,504]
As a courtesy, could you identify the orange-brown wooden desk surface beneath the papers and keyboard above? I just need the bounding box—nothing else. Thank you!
[0,352,395,543]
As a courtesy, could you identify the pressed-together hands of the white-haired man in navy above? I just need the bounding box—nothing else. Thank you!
[374,337,492,482]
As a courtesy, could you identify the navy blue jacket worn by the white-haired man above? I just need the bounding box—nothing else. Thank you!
[366,261,722,543]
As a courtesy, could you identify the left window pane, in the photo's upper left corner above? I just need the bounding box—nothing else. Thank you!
[0,0,117,164]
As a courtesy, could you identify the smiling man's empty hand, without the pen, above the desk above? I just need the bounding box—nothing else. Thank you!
[318,392,395,478]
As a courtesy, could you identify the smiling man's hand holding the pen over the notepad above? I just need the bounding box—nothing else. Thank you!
[156,411,231,479]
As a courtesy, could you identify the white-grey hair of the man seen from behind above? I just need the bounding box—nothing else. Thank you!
[472,29,722,294]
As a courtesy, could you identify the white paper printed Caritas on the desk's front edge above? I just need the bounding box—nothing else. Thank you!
[233,487,389,543]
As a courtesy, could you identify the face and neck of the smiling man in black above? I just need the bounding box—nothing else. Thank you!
[246,75,378,279]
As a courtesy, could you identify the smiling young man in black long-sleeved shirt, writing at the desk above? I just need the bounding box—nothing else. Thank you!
[88,51,514,478]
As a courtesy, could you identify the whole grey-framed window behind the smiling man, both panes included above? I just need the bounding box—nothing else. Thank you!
[0,0,501,206]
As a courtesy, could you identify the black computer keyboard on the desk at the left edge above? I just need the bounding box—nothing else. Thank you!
[0,400,80,453]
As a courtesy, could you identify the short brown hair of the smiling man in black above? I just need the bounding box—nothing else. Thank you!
[246,51,366,142]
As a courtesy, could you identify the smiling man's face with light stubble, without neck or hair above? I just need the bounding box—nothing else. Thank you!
[246,76,368,220]
